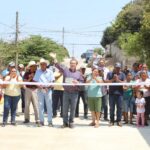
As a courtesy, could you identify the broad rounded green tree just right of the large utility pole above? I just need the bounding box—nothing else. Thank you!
[19,36,69,63]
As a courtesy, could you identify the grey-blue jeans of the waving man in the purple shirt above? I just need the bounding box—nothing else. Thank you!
[63,91,78,124]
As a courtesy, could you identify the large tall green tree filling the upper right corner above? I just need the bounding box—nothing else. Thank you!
[101,0,150,66]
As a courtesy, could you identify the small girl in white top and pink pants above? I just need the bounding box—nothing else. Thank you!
[135,91,145,127]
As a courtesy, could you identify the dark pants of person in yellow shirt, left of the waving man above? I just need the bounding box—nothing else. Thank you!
[53,90,63,116]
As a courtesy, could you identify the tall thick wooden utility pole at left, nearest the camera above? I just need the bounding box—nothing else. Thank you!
[15,11,19,69]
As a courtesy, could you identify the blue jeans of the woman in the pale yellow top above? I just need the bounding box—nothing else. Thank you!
[3,95,20,123]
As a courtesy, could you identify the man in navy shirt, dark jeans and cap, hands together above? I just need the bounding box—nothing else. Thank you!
[106,63,126,127]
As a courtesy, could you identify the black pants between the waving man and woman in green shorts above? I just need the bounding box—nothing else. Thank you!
[75,91,88,116]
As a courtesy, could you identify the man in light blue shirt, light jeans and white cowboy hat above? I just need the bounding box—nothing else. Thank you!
[33,58,55,127]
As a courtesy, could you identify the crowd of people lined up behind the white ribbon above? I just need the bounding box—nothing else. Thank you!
[0,53,150,128]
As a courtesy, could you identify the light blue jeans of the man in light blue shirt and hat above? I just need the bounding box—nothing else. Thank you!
[37,89,52,123]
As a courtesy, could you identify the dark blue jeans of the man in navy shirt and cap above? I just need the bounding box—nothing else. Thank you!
[109,94,123,122]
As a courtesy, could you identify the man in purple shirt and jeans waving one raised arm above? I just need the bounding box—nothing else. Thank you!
[50,53,84,128]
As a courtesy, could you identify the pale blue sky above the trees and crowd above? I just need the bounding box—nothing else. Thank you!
[0,0,131,58]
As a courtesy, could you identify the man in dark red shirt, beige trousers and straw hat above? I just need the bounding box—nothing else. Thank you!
[24,61,39,125]
